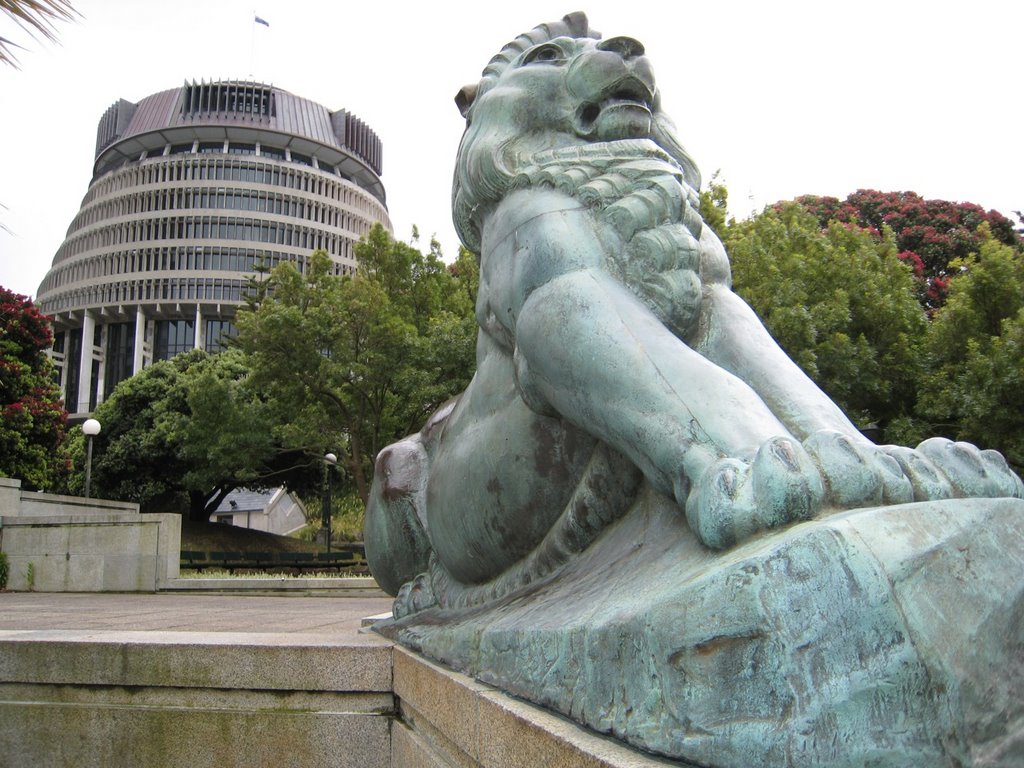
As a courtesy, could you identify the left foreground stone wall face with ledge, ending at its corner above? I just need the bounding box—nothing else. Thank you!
[0,630,394,768]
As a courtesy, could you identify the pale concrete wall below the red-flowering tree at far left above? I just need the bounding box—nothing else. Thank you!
[0,478,181,592]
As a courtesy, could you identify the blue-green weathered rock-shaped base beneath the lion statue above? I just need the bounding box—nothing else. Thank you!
[384,495,1024,768]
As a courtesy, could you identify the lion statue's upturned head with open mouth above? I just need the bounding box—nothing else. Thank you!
[452,12,700,253]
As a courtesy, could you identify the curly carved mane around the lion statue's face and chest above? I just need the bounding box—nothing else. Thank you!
[453,12,716,338]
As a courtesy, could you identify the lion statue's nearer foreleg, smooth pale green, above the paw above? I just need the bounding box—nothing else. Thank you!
[515,269,787,502]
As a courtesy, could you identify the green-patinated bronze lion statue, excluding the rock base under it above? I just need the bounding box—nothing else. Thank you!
[366,13,1024,616]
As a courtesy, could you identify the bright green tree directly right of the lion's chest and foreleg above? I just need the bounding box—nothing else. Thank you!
[725,203,927,438]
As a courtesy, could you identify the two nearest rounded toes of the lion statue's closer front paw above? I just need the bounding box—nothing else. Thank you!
[686,437,824,549]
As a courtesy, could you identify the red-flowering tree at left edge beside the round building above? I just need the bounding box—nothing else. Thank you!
[0,287,69,489]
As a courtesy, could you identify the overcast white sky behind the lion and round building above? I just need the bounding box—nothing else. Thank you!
[0,0,1024,296]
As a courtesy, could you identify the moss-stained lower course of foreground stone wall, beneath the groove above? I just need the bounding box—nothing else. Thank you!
[0,684,392,768]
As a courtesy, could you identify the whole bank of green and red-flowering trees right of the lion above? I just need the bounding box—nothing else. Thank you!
[716,181,1024,469]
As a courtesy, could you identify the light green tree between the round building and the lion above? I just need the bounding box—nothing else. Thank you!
[238,231,476,501]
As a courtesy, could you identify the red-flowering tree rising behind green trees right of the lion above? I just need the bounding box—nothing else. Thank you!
[790,189,1022,312]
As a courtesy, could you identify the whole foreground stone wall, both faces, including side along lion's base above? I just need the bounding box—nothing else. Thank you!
[0,629,680,768]
